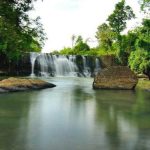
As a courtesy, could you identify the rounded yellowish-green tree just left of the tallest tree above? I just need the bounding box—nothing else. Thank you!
[96,23,114,52]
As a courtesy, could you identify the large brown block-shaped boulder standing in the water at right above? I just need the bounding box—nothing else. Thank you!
[93,66,138,90]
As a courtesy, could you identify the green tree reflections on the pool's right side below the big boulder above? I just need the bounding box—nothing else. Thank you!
[95,90,150,150]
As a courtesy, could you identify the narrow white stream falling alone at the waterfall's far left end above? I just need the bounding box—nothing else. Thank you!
[30,52,39,77]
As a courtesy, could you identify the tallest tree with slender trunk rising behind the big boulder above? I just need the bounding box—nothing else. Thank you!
[107,0,135,64]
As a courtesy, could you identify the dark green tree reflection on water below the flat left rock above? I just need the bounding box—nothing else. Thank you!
[0,92,33,150]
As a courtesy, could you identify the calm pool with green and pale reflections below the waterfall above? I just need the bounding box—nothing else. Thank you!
[0,78,150,150]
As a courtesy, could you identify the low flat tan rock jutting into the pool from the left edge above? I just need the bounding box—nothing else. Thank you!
[0,77,55,93]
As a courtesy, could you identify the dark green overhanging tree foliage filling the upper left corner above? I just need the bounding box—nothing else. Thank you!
[0,0,46,59]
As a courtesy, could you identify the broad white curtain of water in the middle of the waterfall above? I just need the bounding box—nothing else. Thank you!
[34,53,78,77]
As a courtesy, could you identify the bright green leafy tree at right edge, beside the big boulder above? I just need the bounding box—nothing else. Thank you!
[129,19,150,79]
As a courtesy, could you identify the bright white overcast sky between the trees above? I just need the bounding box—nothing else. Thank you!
[31,0,140,52]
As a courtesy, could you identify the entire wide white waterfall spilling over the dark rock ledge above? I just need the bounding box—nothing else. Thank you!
[30,53,100,77]
